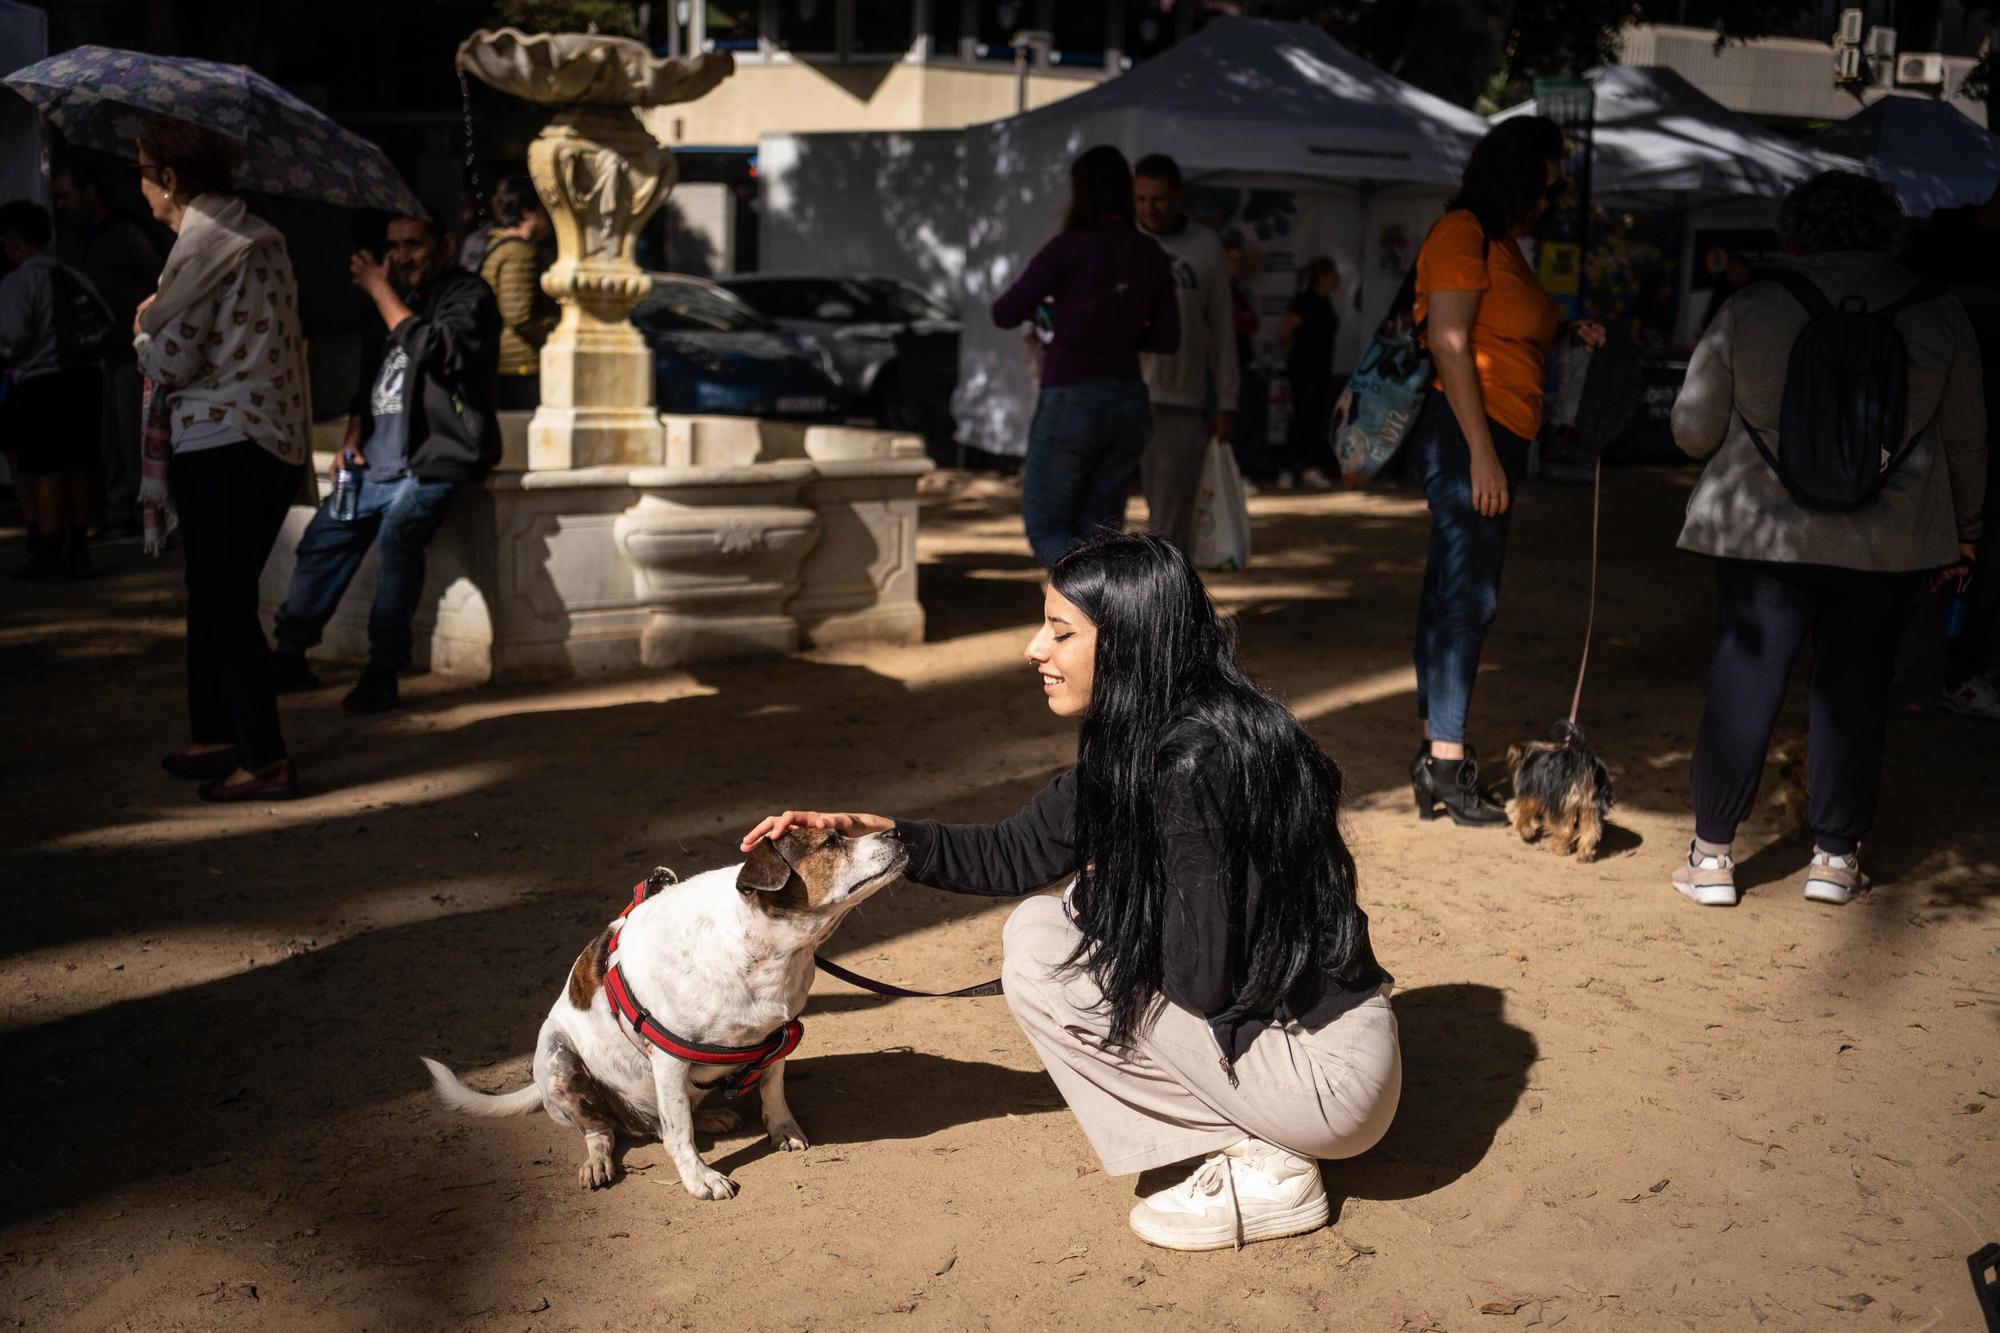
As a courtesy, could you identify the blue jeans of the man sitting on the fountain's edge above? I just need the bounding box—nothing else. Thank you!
[278,472,458,671]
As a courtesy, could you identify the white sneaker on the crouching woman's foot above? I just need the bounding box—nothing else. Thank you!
[1132,1139,1332,1249]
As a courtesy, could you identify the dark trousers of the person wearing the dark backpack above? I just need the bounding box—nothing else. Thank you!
[1694,560,1922,855]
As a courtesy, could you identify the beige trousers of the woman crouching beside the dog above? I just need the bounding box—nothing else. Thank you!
[1002,897,1402,1175]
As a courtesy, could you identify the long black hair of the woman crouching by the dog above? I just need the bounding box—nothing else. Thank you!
[1048,534,1364,1045]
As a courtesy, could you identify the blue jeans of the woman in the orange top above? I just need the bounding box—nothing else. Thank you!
[1410,388,1528,743]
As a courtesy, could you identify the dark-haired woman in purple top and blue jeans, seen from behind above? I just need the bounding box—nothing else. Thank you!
[994,144,1180,568]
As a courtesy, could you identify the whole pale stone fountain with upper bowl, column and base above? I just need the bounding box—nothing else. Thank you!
[262,28,932,681]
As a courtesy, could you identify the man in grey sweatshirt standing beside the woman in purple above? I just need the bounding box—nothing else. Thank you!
[1132,152,1238,554]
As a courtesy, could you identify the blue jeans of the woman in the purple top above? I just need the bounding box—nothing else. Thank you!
[1020,380,1152,568]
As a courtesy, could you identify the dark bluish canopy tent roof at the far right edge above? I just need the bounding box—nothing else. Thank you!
[1808,94,2000,218]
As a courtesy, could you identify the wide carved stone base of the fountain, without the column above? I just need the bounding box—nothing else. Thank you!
[260,412,934,681]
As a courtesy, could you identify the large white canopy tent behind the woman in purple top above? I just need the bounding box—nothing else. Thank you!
[954,18,1486,454]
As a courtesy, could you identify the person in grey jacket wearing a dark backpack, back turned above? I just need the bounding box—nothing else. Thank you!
[1672,172,1986,907]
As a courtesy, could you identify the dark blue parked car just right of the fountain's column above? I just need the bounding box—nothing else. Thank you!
[632,272,840,418]
